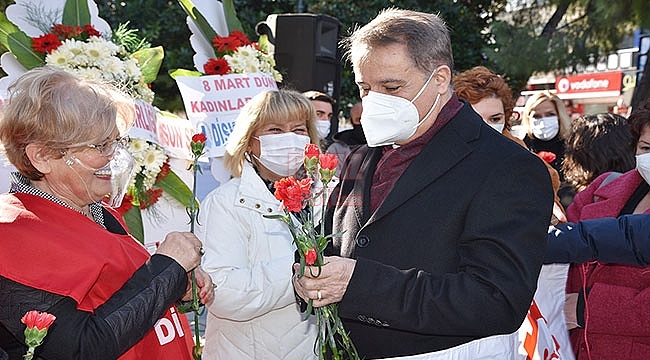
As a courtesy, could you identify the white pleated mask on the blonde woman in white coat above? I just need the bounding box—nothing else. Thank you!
[255,132,309,176]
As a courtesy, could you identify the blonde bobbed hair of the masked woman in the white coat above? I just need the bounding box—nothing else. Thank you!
[223,90,318,177]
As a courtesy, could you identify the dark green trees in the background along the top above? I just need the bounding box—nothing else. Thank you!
[0,0,650,115]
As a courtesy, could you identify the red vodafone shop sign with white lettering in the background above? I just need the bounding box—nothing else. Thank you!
[555,71,623,98]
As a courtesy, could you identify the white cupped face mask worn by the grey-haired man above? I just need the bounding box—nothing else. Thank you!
[361,71,440,147]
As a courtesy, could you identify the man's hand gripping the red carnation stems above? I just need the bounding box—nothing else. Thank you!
[292,256,357,307]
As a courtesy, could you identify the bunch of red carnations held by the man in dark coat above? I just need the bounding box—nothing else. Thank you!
[266,144,359,359]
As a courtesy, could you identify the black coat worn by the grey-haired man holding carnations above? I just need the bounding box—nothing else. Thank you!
[326,103,553,358]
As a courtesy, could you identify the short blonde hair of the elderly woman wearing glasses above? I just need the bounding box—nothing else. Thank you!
[0,66,135,180]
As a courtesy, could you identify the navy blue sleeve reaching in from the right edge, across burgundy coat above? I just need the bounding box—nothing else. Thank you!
[544,214,650,266]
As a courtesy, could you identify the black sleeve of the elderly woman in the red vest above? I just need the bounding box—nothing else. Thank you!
[0,255,188,360]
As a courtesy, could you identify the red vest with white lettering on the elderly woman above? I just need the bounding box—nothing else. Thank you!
[0,193,193,360]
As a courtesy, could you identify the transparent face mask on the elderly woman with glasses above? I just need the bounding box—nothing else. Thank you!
[66,145,135,208]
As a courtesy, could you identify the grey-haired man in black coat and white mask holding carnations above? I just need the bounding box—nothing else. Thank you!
[294,9,553,359]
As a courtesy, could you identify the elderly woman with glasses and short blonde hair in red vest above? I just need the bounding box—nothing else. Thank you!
[0,67,214,359]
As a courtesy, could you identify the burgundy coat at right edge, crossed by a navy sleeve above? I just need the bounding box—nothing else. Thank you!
[567,170,650,360]
